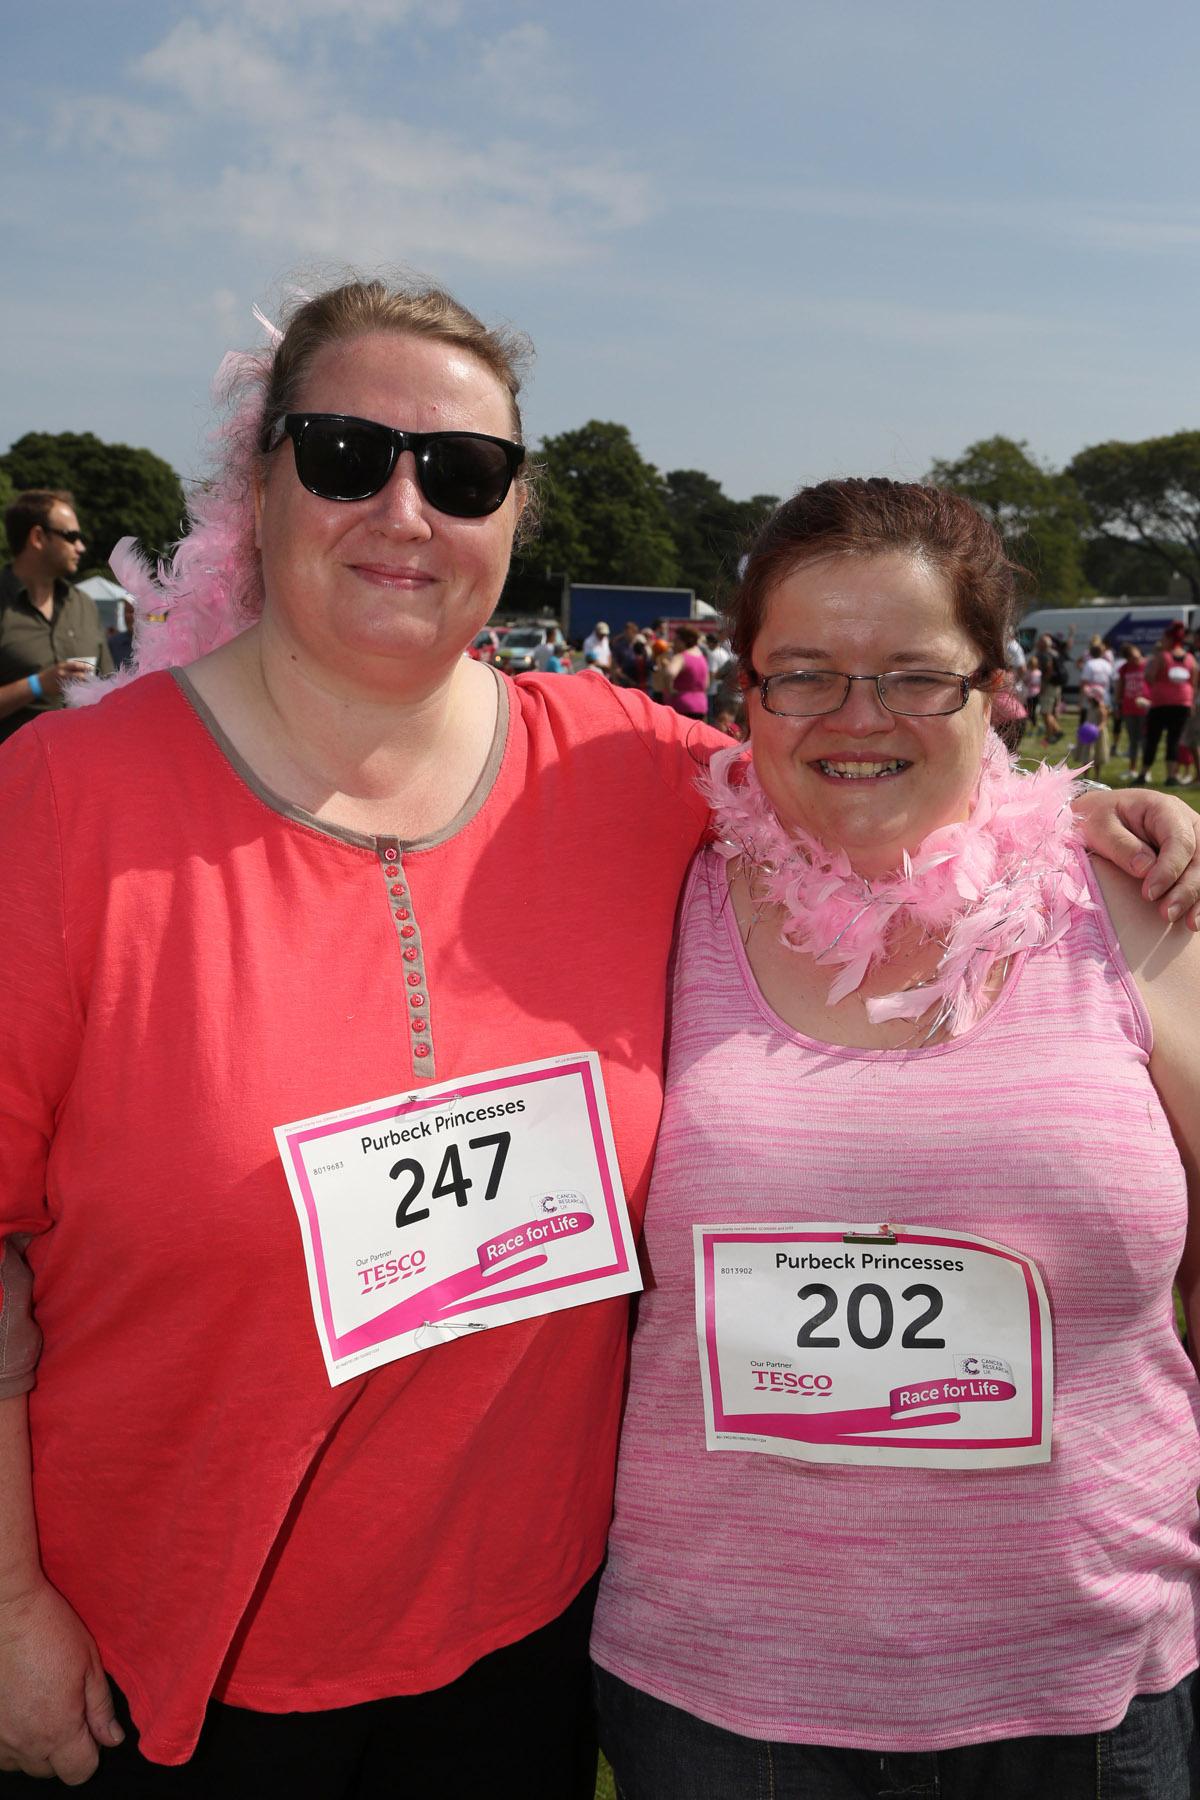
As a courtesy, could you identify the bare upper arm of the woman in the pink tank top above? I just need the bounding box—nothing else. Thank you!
[1096,864,1200,1368]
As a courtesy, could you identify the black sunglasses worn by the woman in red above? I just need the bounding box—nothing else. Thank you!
[266,412,525,518]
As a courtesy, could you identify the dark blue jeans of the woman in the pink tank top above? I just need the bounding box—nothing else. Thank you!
[596,1669,1200,1800]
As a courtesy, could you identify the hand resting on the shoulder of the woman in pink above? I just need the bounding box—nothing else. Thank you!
[1074,788,1200,931]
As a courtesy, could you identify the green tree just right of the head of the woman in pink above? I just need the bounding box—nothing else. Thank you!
[928,437,1088,605]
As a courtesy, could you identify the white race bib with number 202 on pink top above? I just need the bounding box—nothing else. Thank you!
[693,1224,1054,1469]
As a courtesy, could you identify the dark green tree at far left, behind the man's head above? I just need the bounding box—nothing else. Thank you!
[0,432,187,567]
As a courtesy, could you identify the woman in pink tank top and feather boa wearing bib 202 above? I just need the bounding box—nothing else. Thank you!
[594,481,1200,1800]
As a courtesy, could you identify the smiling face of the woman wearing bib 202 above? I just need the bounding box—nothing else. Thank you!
[748,554,990,875]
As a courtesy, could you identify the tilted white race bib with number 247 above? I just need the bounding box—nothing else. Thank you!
[275,1051,642,1386]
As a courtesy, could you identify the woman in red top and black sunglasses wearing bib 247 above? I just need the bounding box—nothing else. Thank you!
[0,283,1195,1800]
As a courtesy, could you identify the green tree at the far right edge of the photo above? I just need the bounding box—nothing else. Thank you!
[1067,432,1200,601]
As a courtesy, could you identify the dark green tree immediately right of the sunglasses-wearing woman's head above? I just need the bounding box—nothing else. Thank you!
[522,419,678,587]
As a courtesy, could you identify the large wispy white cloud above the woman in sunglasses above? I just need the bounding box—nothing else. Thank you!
[51,0,655,270]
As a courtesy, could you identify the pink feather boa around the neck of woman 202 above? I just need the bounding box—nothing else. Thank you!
[700,733,1090,1037]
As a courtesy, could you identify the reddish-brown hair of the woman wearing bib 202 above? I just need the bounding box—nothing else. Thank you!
[729,475,1024,680]
